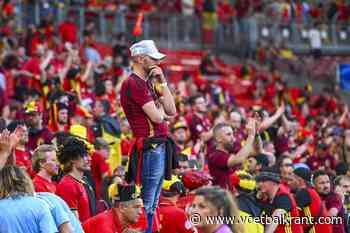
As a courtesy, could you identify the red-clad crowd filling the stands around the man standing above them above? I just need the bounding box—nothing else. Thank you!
[0,1,350,233]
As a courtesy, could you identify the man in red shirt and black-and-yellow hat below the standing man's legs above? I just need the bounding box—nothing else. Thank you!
[83,184,143,233]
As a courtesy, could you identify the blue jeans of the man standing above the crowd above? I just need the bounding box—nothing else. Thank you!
[141,143,165,233]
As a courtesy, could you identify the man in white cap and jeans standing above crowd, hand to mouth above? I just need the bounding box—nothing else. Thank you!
[120,40,176,232]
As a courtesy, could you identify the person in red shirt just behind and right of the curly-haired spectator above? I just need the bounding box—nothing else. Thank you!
[91,138,109,200]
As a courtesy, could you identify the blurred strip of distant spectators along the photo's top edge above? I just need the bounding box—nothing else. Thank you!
[0,0,350,23]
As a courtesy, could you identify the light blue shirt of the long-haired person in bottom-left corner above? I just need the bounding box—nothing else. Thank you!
[0,196,58,233]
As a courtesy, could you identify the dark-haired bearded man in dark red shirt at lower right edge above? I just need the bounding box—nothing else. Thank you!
[313,170,345,233]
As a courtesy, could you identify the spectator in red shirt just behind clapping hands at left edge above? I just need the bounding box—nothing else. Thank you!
[7,121,34,176]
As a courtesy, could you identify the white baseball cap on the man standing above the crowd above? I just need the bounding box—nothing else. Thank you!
[130,40,166,60]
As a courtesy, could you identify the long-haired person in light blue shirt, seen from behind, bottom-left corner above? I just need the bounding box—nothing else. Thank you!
[0,166,58,233]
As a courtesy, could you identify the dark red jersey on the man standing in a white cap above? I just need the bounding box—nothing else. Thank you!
[120,74,168,138]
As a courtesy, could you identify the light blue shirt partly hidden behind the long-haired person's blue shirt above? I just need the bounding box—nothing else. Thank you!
[36,192,84,233]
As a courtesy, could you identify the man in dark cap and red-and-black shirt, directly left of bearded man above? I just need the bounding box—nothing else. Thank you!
[288,167,332,233]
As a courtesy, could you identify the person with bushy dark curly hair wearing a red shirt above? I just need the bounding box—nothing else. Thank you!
[56,137,95,222]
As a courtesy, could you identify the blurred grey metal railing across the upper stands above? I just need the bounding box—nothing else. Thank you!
[6,0,350,54]
